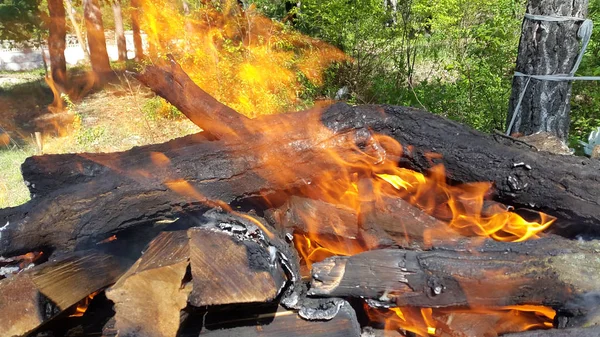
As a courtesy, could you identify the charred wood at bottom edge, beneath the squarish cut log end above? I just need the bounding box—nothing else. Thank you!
[200,303,361,337]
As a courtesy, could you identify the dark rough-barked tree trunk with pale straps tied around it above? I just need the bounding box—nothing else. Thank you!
[507,0,588,141]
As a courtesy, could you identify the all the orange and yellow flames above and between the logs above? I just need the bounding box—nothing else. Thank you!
[131,0,554,336]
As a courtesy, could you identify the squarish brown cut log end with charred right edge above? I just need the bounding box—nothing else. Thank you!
[188,228,286,307]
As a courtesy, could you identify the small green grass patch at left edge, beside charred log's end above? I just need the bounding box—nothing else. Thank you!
[0,147,34,208]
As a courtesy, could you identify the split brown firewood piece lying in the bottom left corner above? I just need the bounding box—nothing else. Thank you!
[0,250,127,336]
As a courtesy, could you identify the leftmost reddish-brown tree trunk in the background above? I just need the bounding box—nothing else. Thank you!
[48,0,67,91]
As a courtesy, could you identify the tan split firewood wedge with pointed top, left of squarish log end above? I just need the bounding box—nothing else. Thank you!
[106,231,191,337]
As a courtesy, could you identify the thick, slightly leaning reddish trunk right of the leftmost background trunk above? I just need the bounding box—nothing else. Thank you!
[83,0,112,81]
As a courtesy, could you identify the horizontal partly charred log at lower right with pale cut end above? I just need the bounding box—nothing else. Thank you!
[309,237,600,311]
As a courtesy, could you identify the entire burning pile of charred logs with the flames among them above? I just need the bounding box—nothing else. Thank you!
[0,3,600,337]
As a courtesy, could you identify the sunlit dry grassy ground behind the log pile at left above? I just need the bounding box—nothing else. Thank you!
[0,70,200,208]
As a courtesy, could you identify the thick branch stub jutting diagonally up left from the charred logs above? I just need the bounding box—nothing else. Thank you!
[136,57,249,138]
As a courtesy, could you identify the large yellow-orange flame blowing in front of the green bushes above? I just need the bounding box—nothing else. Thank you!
[136,0,348,117]
